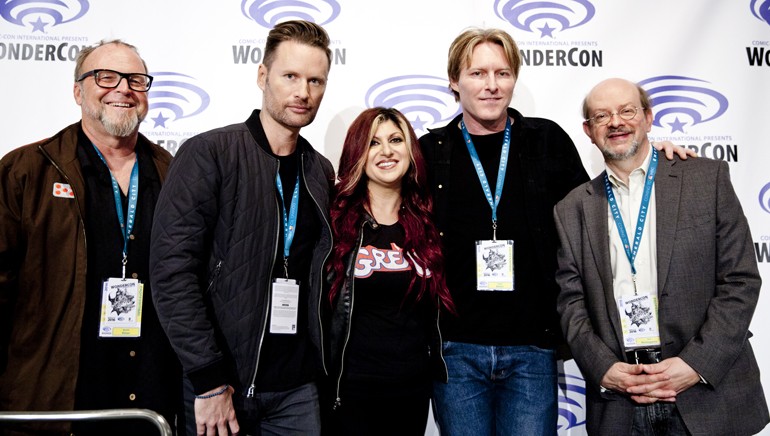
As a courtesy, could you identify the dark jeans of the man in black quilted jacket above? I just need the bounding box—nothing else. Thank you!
[184,377,321,436]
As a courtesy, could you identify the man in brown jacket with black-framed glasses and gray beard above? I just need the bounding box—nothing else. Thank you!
[0,40,184,435]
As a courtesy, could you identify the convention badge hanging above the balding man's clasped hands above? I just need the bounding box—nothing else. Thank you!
[617,294,660,350]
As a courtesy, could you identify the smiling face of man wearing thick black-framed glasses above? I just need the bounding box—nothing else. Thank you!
[74,43,148,138]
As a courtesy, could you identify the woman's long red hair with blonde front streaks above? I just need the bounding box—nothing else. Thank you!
[328,107,454,312]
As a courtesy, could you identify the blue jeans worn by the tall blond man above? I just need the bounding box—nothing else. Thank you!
[433,341,558,436]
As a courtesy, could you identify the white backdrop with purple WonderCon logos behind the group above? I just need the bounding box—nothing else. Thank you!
[0,0,770,435]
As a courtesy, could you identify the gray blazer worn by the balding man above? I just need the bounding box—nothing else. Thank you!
[554,153,770,435]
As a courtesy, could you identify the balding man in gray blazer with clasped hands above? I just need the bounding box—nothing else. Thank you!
[554,79,770,435]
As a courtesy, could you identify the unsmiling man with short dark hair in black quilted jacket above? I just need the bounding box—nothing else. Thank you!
[151,21,334,435]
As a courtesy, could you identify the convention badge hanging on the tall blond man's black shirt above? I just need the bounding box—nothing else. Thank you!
[476,240,514,291]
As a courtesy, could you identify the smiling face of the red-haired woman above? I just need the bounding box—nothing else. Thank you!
[365,120,411,192]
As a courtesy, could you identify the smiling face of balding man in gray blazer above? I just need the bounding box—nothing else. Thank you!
[583,79,652,161]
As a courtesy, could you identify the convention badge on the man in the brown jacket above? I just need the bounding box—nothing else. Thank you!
[99,278,144,338]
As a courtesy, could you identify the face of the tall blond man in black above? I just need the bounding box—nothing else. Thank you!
[450,42,516,134]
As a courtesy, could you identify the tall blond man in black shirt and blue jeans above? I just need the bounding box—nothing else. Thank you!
[420,29,684,435]
